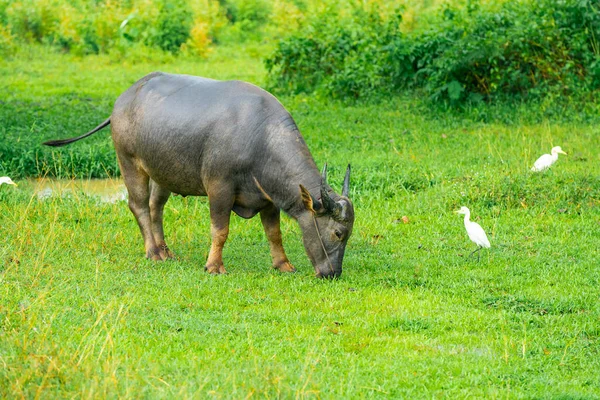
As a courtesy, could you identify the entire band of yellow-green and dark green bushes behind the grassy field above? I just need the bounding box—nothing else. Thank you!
[0,0,600,104]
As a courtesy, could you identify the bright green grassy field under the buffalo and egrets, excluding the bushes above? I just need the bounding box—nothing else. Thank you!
[0,44,600,399]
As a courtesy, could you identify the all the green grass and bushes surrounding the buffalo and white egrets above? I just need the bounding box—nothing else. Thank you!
[0,0,600,398]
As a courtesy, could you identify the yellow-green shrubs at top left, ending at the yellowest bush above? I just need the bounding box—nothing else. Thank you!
[0,0,227,54]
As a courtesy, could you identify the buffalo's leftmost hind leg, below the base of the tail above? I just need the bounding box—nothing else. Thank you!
[119,158,166,260]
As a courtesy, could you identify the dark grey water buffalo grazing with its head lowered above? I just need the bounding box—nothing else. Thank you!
[44,72,354,278]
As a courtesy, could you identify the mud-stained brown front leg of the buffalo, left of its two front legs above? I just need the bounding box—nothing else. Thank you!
[204,185,234,274]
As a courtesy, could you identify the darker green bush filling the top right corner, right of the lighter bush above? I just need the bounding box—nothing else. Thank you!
[411,0,600,101]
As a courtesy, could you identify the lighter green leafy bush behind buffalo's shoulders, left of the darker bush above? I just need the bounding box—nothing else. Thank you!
[266,4,401,97]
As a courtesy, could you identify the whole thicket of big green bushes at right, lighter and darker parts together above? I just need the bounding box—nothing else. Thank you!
[266,0,600,102]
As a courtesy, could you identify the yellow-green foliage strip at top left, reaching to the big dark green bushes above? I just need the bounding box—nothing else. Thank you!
[0,0,315,59]
